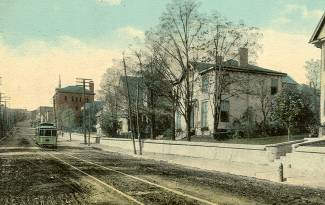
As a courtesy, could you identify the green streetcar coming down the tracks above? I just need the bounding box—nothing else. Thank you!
[36,123,58,147]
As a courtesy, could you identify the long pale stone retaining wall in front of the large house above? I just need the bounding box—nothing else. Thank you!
[101,138,301,164]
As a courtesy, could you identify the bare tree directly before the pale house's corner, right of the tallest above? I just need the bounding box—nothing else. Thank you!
[203,12,261,138]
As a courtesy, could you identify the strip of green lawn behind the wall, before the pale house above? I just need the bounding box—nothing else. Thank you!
[183,134,308,145]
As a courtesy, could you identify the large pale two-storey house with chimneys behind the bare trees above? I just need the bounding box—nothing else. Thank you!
[175,48,290,135]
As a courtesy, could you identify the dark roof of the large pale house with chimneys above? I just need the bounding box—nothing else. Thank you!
[192,60,287,76]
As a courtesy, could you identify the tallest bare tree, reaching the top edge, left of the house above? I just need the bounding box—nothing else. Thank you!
[147,0,204,141]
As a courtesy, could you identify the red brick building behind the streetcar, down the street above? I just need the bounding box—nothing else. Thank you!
[53,82,95,126]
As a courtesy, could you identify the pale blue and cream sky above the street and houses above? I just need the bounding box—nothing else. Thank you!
[0,0,325,110]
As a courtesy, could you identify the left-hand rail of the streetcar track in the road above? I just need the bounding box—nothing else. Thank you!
[47,153,144,205]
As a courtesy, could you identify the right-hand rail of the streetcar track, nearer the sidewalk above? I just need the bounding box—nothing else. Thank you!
[58,153,217,205]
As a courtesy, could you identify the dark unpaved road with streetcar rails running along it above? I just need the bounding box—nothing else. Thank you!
[0,123,325,205]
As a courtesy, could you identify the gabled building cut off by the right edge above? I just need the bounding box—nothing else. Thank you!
[309,13,325,125]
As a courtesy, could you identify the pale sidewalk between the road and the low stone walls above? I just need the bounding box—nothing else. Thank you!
[58,133,325,189]
